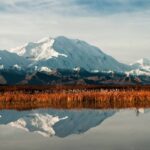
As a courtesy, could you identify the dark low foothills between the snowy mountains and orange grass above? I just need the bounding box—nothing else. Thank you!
[0,68,150,85]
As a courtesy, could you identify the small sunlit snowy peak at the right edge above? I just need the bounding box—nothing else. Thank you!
[128,58,150,76]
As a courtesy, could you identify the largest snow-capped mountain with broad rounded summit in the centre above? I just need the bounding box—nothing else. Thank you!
[10,36,130,72]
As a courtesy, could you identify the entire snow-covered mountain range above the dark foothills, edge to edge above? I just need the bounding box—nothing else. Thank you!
[0,36,150,79]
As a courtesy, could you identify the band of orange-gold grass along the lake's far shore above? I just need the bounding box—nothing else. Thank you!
[0,84,150,110]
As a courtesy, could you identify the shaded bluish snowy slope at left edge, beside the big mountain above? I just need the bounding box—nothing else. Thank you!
[0,50,29,69]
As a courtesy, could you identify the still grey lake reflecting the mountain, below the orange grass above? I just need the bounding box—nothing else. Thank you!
[0,108,150,150]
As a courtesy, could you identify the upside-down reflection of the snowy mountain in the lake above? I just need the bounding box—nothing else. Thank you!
[0,109,116,137]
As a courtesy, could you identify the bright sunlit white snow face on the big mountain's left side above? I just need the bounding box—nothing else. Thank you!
[10,37,67,61]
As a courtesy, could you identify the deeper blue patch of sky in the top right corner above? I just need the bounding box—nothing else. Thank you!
[74,0,150,14]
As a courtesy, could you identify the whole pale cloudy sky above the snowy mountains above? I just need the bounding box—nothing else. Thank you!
[0,0,150,63]
